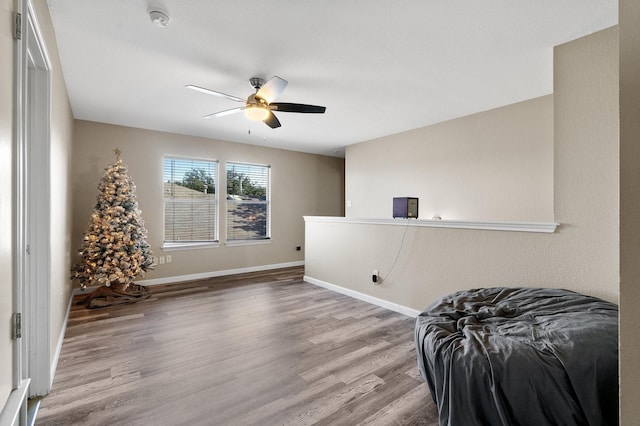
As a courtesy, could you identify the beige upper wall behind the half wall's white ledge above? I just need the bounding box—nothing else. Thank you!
[346,95,553,222]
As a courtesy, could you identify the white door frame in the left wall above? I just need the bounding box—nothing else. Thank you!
[14,0,51,397]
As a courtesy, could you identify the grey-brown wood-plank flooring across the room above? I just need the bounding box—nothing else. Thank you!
[35,267,438,426]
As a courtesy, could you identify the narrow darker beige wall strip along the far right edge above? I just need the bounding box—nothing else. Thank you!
[619,0,640,425]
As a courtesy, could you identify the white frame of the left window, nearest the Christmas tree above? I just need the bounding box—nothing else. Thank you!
[162,154,220,251]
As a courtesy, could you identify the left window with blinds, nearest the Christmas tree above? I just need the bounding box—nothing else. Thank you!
[163,157,218,247]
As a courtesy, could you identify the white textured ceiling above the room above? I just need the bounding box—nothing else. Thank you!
[48,0,618,156]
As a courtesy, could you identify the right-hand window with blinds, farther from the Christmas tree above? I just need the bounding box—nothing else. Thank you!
[227,163,271,242]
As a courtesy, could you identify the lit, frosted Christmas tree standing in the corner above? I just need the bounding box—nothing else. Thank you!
[71,149,153,307]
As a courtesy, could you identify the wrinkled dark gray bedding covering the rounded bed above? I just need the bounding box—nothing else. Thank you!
[415,287,618,426]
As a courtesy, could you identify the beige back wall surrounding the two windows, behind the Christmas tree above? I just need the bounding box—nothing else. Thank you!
[72,121,344,279]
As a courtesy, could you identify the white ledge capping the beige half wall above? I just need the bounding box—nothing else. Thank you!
[304,216,560,234]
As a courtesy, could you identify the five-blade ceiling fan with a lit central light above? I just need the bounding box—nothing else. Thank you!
[185,76,326,129]
